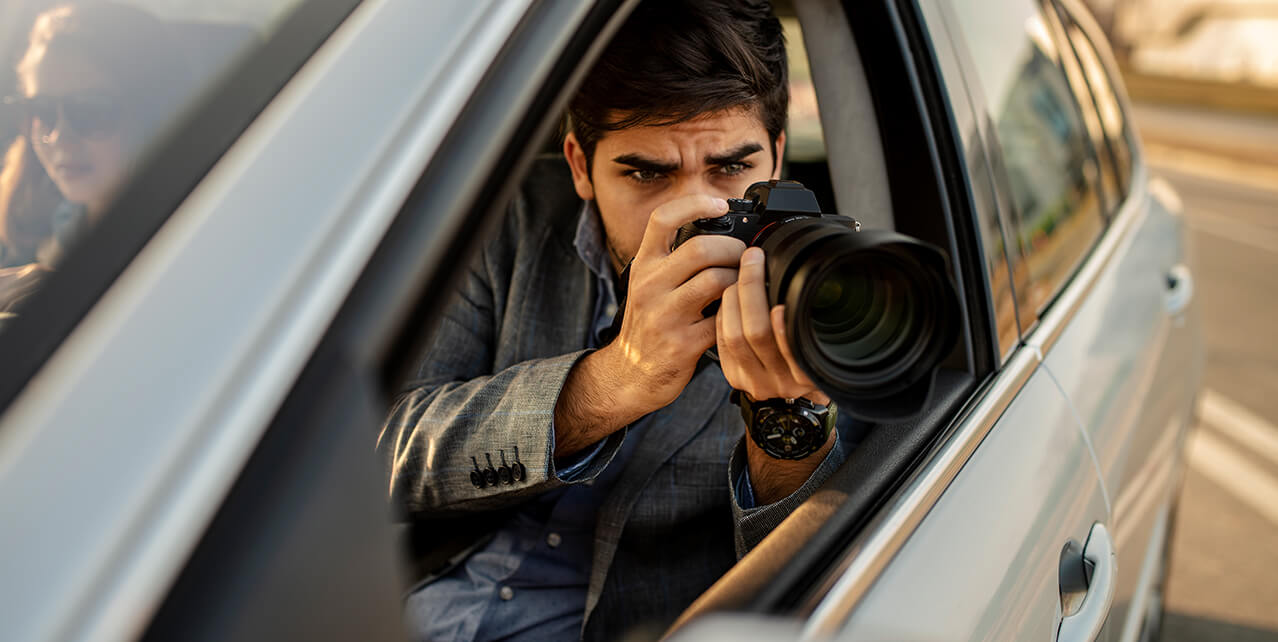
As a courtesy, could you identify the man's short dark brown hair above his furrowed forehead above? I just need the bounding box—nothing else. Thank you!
[567,0,790,173]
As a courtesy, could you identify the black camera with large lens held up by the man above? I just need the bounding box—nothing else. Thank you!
[674,180,962,422]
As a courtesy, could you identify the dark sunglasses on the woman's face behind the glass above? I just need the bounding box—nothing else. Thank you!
[4,95,121,143]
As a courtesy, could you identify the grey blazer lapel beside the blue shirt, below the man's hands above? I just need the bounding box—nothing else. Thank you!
[581,363,731,630]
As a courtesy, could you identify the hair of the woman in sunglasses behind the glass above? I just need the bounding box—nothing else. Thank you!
[0,0,188,262]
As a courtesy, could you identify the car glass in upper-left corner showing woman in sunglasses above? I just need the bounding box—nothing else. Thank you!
[0,0,300,330]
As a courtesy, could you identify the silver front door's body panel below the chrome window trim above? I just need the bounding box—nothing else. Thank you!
[838,350,1107,641]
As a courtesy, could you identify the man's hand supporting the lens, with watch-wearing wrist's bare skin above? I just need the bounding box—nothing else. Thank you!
[714,248,838,504]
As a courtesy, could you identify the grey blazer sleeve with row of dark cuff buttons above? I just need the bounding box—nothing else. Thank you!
[377,195,625,517]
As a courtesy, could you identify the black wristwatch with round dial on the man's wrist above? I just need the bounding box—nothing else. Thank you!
[732,390,838,459]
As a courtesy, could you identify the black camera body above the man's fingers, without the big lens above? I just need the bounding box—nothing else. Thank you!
[671,179,861,249]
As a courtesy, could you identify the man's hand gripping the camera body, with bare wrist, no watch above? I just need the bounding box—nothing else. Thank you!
[555,196,745,457]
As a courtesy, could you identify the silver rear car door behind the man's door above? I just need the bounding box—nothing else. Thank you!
[1030,3,1203,641]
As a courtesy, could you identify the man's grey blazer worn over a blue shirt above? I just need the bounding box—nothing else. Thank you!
[377,159,843,639]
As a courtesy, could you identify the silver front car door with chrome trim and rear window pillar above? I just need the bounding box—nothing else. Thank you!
[777,3,1113,639]
